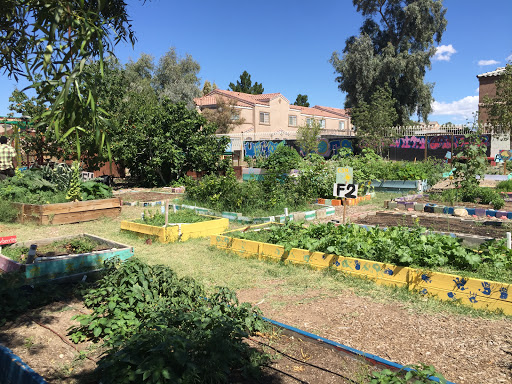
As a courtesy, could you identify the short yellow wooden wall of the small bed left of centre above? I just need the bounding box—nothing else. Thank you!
[121,215,229,243]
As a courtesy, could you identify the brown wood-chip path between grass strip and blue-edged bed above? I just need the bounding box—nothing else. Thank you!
[238,281,512,384]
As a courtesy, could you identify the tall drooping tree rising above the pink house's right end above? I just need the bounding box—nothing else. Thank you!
[330,0,447,124]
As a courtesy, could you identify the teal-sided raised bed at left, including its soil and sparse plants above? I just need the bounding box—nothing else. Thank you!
[0,234,133,283]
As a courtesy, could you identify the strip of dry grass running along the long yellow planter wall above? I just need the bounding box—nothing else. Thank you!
[2,207,506,319]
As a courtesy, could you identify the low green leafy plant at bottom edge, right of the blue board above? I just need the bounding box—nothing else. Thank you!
[370,364,446,384]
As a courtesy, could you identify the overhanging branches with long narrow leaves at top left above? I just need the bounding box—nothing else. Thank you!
[0,0,140,153]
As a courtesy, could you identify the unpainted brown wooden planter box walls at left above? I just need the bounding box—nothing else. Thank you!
[13,197,122,224]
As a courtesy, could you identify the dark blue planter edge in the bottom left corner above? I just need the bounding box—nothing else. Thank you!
[0,344,47,384]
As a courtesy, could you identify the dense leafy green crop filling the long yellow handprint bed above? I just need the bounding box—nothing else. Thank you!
[235,222,512,281]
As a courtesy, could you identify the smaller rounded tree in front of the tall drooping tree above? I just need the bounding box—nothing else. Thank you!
[351,84,398,155]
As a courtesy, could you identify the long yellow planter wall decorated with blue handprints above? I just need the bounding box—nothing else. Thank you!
[210,235,512,315]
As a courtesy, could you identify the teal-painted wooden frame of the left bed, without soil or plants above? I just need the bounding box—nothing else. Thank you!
[0,233,133,283]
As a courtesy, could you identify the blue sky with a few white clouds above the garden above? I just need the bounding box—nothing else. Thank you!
[0,0,512,123]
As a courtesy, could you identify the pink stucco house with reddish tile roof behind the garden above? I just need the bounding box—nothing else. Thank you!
[194,89,354,137]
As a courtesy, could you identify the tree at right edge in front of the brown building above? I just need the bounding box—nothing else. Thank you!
[484,64,512,132]
